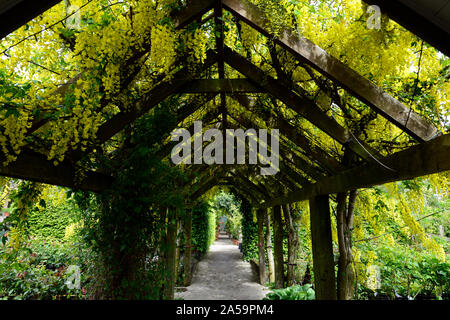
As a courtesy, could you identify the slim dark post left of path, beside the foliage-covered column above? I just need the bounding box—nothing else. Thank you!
[164,208,177,300]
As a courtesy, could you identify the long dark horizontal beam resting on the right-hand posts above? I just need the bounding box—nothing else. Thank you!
[261,134,450,208]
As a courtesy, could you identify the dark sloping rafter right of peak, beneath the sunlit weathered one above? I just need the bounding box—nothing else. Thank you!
[224,47,377,161]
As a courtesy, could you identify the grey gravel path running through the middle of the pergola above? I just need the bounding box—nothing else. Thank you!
[176,235,269,300]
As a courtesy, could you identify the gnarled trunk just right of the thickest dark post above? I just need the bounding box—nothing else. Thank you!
[336,190,357,300]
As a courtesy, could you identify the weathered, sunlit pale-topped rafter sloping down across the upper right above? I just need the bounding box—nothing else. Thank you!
[223,0,438,141]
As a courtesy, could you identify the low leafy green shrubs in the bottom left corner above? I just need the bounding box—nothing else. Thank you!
[0,241,90,300]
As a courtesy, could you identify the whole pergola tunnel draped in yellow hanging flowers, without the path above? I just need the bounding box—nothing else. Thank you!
[0,0,450,300]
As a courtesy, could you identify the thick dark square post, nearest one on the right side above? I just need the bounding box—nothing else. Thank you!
[309,195,336,300]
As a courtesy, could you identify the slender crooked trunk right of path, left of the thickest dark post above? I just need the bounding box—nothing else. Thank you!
[283,204,299,287]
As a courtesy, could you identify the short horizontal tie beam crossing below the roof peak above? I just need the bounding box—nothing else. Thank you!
[178,79,265,93]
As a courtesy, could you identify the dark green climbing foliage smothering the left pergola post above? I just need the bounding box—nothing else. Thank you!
[77,104,185,299]
